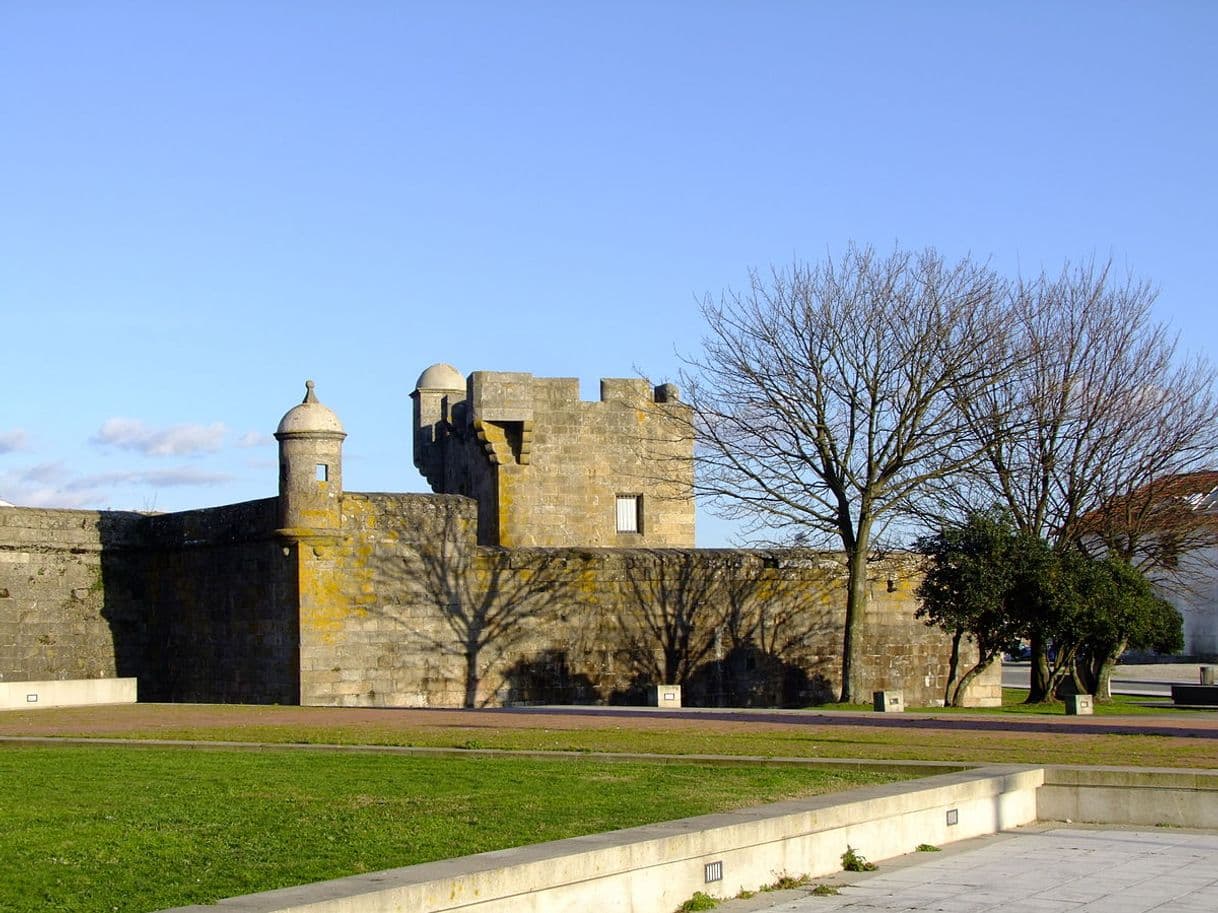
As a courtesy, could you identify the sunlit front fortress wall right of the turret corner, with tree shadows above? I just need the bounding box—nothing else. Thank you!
[301,494,994,707]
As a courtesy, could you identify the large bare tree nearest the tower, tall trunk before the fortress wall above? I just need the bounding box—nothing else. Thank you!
[682,246,1006,701]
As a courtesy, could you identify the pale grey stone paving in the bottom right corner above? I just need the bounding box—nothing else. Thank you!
[717,824,1218,913]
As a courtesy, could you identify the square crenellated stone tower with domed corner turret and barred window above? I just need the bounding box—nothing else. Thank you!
[412,365,694,548]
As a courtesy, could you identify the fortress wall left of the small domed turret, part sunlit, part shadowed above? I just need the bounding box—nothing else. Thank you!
[0,498,298,702]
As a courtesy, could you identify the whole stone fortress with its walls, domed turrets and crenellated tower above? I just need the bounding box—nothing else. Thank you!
[0,364,1000,707]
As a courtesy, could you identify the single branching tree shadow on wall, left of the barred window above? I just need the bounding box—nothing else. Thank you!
[404,511,580,707]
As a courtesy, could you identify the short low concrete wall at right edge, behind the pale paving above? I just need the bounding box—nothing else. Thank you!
[1037,767,1218,828]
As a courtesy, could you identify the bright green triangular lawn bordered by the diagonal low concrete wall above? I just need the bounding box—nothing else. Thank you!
[0,746,898,913]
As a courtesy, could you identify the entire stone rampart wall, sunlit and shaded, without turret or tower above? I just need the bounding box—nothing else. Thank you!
[0,493,998,707]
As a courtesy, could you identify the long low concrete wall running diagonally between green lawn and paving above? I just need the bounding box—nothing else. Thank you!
[159,767,1044,913]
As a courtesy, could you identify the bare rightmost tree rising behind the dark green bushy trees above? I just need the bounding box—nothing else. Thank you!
[957,263,1218,701]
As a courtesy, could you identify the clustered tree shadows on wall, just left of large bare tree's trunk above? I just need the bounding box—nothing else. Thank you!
[610,550,836,706]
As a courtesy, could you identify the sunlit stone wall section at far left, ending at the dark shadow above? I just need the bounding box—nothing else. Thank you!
[0,508,144,682]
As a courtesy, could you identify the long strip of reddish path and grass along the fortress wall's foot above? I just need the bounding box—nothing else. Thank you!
[9,693,1218,769]
